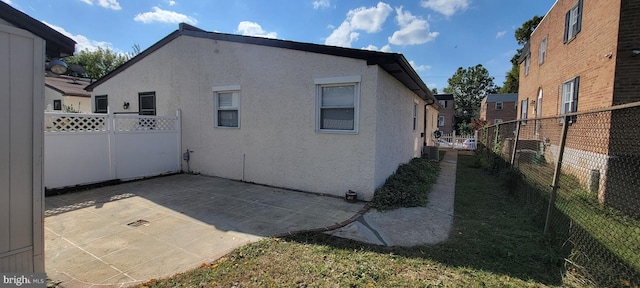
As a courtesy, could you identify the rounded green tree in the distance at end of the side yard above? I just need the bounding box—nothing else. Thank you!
[444,64,498,133]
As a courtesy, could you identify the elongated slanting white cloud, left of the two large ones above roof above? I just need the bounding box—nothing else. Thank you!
[325,2,393,47]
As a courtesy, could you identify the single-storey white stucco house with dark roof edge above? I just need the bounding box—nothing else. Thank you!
[87,23,438,200]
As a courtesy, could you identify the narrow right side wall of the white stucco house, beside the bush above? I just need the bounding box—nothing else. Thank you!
[375,70,428,187]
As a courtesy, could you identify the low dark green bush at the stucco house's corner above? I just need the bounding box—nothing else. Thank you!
[371,158,440,211]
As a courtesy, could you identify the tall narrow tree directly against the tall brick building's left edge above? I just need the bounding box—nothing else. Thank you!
[500,15,542,93]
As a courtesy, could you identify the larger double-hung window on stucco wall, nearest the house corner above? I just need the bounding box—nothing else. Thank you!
[315,76,361,133]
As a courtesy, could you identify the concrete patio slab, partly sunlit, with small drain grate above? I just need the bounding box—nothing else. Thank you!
[45,174,365,287]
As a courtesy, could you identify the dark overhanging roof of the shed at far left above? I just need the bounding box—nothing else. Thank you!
[0,1,76,58]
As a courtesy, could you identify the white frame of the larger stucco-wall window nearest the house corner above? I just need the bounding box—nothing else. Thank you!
[314,75,362,134]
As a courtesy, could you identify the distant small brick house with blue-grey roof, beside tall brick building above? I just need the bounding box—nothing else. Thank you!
[480,93,518,125]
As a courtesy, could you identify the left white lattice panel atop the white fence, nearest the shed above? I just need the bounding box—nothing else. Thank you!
[44,114,107,132]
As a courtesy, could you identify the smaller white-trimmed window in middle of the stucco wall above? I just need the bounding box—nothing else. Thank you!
[213,85,240,128]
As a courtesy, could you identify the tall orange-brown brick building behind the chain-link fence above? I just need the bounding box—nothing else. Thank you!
[518,0,640,213]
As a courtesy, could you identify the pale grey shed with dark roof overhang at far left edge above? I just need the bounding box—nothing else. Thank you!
[0,1,75,272]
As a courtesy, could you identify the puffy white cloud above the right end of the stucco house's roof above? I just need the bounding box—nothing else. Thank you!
[389,7,439,45]
